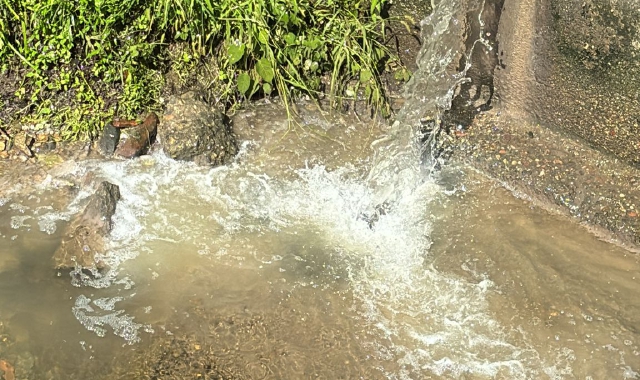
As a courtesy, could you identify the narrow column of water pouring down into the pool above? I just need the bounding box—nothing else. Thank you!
[367,0,465,211]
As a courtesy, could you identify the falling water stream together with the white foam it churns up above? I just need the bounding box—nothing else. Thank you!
[0,1,584,379]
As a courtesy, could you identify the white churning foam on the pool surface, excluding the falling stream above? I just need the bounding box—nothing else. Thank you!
[50,140,556,379]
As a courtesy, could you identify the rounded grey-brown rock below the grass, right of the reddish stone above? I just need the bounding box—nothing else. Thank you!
[160,92,237,165]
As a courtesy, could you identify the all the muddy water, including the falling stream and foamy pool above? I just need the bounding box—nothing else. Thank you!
[0,1,640,379]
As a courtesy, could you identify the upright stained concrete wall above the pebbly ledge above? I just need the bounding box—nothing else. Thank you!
[494,0,640,165]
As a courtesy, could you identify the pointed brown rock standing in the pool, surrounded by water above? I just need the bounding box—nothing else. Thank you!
[53,181,120,269]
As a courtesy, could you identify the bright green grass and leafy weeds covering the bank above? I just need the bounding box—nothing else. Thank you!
[0,0,410,139]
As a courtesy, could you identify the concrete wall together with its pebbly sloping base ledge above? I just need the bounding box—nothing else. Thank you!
[444,0,640,247]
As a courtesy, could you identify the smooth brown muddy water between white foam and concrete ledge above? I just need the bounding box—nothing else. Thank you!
[430,170,640,379]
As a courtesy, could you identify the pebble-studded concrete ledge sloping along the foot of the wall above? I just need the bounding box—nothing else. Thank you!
[452,112,640,249]
